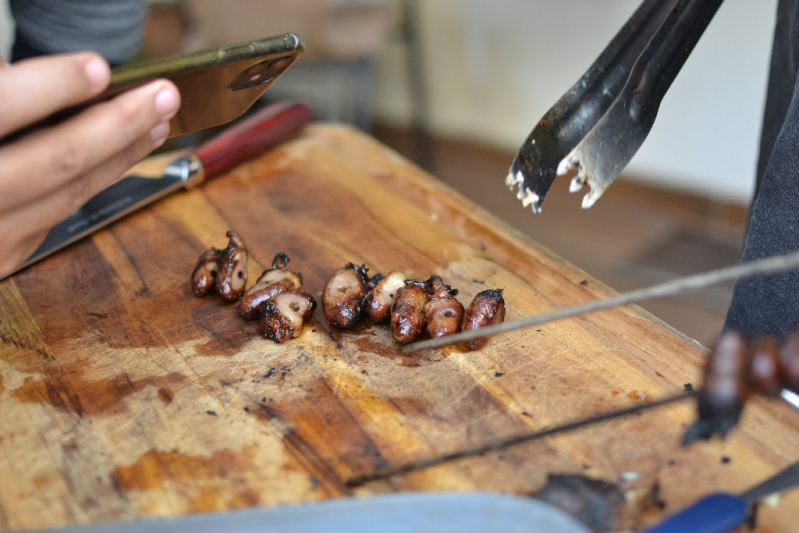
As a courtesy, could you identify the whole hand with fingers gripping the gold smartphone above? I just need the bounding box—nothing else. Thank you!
[0,53,180,277]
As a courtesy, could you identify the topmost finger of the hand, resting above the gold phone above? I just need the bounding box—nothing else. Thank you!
[0,53,111,137]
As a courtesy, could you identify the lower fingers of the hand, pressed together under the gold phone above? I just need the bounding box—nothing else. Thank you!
[0,76,180,278]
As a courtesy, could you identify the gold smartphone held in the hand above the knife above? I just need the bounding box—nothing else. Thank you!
[104,33,305,137]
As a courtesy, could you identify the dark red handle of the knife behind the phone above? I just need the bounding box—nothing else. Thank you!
[194,102,313,179]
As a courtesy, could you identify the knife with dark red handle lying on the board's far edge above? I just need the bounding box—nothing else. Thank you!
[8,102,313,279]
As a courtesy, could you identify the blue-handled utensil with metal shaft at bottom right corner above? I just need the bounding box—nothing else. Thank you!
[644,462,799,533]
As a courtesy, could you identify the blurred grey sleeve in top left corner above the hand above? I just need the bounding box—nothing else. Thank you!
[9,0,147,63]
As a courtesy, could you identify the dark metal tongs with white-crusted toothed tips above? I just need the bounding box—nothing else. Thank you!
[506,0,722,213]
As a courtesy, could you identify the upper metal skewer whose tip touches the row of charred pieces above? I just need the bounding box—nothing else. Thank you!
[399,251,799,353]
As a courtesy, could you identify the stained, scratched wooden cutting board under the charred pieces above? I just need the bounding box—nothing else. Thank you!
[0,125,799,532]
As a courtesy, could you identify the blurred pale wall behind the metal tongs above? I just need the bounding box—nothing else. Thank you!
[376,0,776,203]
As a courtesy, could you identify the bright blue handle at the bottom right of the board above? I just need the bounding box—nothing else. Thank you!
[644,493,747,533]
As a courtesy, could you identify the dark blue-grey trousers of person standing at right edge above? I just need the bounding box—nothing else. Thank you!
[725,0,799,338]
